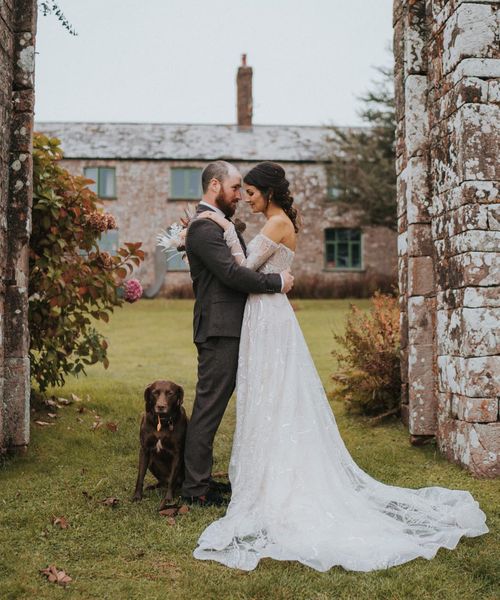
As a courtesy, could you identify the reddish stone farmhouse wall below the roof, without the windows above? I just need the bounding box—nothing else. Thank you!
[55,157,397,295]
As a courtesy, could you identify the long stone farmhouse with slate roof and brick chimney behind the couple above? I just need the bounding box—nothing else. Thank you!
[36,58,397,296]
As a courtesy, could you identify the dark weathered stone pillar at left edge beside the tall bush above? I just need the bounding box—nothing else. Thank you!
[0,0,37,451]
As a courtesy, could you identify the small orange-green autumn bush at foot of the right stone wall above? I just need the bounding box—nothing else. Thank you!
[332,292,401,416]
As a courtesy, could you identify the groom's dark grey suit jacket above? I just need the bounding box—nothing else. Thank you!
[186,205,281,343]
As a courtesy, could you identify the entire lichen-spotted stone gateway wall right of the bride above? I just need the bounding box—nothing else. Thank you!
[394,0,500,477]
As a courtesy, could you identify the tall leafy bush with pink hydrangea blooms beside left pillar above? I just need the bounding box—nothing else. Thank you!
[29,134,144,392]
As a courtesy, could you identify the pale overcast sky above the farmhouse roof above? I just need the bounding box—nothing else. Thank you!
[35,0,392,125]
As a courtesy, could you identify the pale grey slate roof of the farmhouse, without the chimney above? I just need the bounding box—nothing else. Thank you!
[35,122,350,162]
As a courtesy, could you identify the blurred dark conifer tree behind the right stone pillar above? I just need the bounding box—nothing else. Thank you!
[329,67,397,230]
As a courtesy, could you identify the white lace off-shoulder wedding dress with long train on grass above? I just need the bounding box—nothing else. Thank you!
[194,227,488,571]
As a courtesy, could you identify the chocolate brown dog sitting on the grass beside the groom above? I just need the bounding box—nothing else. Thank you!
[132,380,188,510]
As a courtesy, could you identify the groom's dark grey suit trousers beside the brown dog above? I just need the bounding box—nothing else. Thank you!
[182,337,240,496]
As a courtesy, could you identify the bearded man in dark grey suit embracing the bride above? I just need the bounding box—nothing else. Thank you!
[182,160,293,506]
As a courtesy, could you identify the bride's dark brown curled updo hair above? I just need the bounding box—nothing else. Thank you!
[243,161,299,232]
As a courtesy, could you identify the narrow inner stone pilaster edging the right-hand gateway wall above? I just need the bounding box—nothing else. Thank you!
[394,0,437,443]
